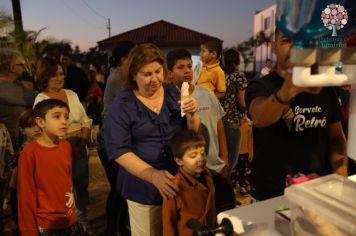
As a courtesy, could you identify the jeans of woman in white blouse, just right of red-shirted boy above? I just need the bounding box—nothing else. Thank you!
[67,137,89,227]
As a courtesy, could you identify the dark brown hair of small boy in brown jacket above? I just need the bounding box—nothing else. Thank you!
[171,130,205,159]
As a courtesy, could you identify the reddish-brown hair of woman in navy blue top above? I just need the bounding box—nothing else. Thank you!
[125,43,167,89]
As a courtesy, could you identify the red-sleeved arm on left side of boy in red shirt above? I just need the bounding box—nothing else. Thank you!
[17,148,38,236]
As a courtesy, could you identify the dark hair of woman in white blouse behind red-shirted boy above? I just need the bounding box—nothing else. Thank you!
[35,57,61,92]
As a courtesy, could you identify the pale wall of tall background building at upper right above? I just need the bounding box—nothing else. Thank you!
[253,4,277,71]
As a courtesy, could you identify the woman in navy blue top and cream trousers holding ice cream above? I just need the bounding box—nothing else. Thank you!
[104,44,200,236]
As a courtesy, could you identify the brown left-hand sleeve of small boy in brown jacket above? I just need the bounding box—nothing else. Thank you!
[162,198,178,236]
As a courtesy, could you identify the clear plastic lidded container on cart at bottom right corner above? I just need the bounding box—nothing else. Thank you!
[284,174,356,236]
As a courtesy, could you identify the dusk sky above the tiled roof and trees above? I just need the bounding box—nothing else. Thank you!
[0,0,276,51]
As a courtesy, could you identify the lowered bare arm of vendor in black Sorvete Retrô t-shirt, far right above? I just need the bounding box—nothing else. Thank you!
[328,122,348,177]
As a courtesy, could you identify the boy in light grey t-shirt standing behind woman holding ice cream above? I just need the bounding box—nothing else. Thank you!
[166,49,236,213]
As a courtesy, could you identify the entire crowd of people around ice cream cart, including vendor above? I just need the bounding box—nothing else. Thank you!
[0,24,348,236]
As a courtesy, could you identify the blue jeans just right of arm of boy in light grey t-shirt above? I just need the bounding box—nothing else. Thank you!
[223,120,241,174]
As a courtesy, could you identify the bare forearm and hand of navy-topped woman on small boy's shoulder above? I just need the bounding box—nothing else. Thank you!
[115,152,178,199]
